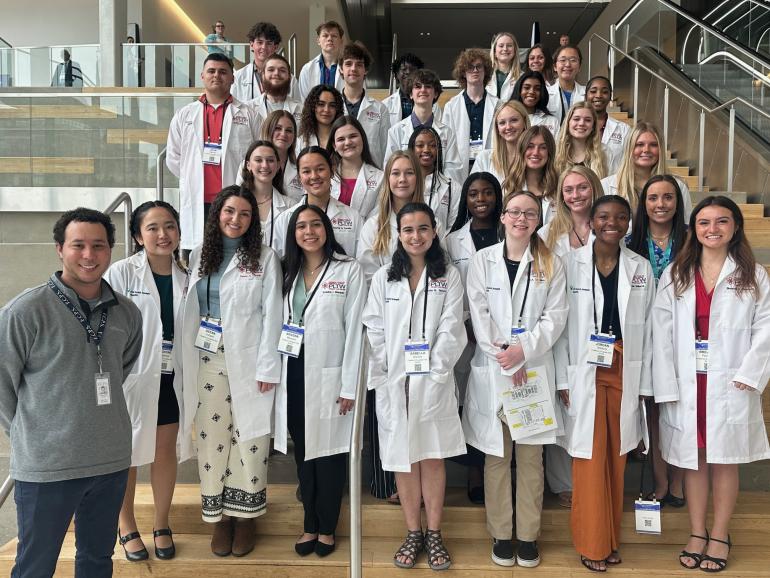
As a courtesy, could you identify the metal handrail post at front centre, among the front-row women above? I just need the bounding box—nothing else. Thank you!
[349,326,368,578]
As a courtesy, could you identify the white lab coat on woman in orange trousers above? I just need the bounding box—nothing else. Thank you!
[554,245,655,459]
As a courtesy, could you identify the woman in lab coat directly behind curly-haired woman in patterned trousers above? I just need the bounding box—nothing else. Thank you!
[241,140,294,247]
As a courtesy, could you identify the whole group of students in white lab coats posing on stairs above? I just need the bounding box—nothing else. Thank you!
[117,23,770,571]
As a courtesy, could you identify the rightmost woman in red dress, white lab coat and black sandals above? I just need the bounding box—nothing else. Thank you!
[653,196,770,572]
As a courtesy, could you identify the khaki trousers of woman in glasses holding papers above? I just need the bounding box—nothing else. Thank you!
[484,414,544,542]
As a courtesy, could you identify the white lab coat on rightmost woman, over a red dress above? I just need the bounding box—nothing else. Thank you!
[652,257,770,470]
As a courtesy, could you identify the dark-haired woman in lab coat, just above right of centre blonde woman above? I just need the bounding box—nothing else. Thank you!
[407,127,462,238]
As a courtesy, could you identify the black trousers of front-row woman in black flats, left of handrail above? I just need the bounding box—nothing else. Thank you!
[286,347,348,534]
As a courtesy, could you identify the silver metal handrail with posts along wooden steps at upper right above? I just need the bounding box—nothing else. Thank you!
[588,33,770,192]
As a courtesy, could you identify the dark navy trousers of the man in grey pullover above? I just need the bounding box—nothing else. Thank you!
[11,470,128,578]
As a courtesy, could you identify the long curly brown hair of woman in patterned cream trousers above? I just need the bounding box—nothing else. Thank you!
[198,185,262,277]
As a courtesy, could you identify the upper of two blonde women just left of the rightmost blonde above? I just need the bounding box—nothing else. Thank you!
[556,100,607,179]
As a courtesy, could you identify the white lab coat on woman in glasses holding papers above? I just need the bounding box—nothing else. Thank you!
[463,242,568,457]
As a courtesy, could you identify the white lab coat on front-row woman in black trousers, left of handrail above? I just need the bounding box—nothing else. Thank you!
[275,255,366,461]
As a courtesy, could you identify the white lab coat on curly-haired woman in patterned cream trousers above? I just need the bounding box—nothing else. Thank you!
[182,245,281,440]
